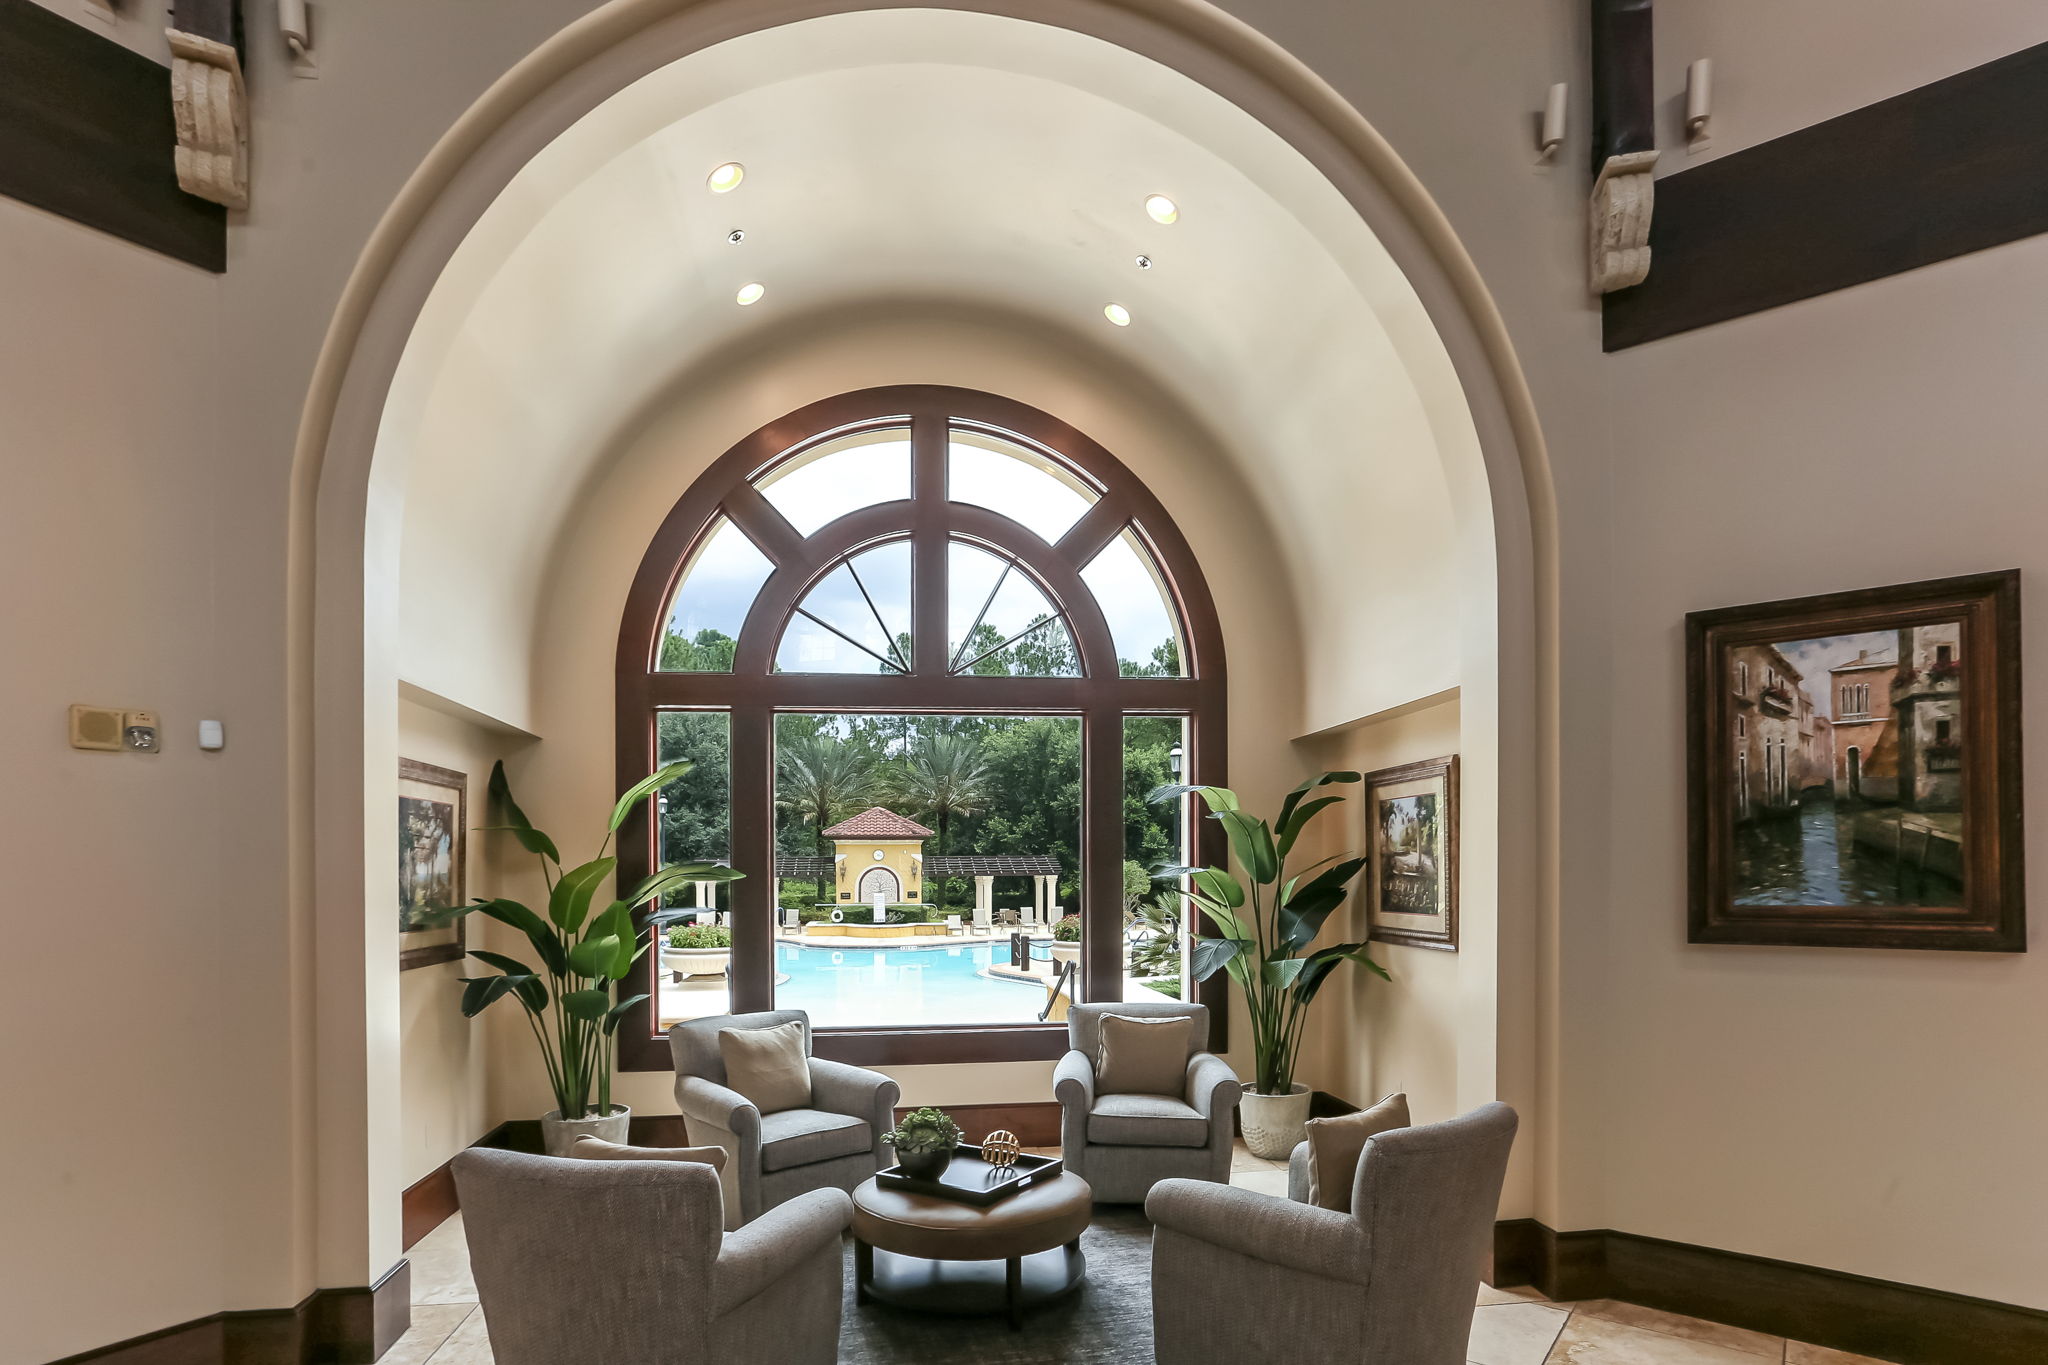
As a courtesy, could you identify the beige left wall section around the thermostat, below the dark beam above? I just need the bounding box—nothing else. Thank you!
[0,199,234,1365]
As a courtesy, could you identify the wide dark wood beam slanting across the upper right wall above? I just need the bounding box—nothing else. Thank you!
[1602,43,2048,352]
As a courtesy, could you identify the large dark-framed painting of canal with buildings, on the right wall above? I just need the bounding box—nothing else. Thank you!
[1686,571,2028,952]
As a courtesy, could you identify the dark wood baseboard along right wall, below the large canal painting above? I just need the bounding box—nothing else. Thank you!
[1491,1218,2048,1365]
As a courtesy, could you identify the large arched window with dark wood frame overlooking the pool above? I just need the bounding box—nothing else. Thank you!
[616,387,1225,1068]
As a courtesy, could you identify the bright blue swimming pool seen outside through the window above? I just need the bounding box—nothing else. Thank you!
[774,939,1044,1027]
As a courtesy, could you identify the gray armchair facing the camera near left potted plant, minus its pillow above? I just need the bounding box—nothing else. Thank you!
[668,1009,901,1228]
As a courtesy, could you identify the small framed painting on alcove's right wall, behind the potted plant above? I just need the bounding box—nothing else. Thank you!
[1364,755,1458,952]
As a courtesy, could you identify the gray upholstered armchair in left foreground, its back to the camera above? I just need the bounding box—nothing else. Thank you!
[453,1148,854,1365]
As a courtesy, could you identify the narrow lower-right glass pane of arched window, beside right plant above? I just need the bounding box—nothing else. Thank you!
[1114,716,1194,1001]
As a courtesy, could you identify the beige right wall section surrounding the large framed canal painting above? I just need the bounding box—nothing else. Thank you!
[1581,237,2048,1308]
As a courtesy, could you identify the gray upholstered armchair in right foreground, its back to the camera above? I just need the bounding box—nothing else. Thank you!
[1145,1105,1516,1365]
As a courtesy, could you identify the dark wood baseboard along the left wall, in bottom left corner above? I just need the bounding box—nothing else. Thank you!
[51,1261,412,1365]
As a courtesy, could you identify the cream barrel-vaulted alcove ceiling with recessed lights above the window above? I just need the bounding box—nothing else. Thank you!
[377,10,1491,731]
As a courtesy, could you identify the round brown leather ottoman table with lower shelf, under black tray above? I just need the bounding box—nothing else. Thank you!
[854,1175,1094,1328]
